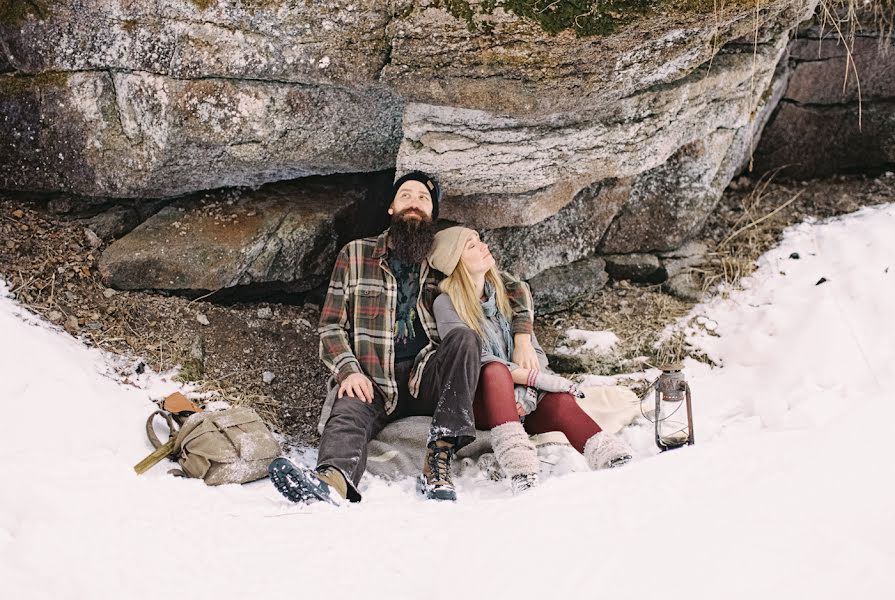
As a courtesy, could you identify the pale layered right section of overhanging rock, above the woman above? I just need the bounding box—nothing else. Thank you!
[383,1,816,277]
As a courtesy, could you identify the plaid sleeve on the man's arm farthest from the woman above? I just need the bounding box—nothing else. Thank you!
[317,246,363,383]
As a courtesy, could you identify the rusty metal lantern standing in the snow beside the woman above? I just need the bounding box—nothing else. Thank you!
[653,364,694,452]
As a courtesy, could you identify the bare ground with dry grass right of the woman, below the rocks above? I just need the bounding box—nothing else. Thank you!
[536,174,895,378]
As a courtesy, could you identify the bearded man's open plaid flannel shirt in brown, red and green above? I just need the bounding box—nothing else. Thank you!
[317,230,534,414]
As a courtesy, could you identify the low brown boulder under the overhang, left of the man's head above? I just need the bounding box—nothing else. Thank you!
[99,176,386,292]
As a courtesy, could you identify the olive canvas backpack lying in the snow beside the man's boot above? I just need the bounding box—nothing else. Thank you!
[138,406,281,485]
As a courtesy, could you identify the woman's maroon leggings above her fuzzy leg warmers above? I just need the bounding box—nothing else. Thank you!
[472,362,601,452]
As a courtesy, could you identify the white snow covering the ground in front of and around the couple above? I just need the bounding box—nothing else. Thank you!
[0,206,895,600]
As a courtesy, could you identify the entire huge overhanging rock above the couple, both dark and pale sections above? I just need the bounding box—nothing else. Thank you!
[0,0,818,289]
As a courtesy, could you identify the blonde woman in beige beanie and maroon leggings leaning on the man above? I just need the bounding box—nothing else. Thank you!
[429,227,631,493]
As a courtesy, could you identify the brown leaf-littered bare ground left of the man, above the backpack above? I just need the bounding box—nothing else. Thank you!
[0,194,326,442]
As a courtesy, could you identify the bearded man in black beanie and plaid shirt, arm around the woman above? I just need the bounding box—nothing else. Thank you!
[269,171,536,502]
